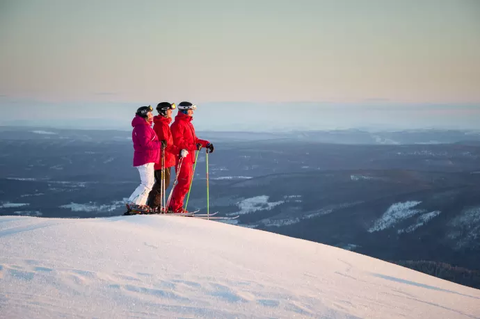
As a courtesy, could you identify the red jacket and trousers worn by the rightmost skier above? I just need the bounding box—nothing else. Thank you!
[169,112,209,212]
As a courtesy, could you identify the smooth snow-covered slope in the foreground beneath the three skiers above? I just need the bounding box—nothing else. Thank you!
[0,216,480,319]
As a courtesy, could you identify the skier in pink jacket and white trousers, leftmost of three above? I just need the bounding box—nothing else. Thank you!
[127,106,161,213]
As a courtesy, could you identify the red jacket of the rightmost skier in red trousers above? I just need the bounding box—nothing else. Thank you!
[170,112,210,163]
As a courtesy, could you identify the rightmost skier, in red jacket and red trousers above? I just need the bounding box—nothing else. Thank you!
[168,102,214,213]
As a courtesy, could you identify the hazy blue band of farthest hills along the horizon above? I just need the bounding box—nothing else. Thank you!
[0,126,480,145]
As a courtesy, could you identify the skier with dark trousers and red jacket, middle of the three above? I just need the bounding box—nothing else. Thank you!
[147,102,180,211]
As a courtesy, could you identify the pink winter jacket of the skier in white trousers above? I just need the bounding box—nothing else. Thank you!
[132,115,161,166]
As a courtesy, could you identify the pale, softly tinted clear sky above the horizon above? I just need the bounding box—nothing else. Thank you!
[0,0,480,128]
